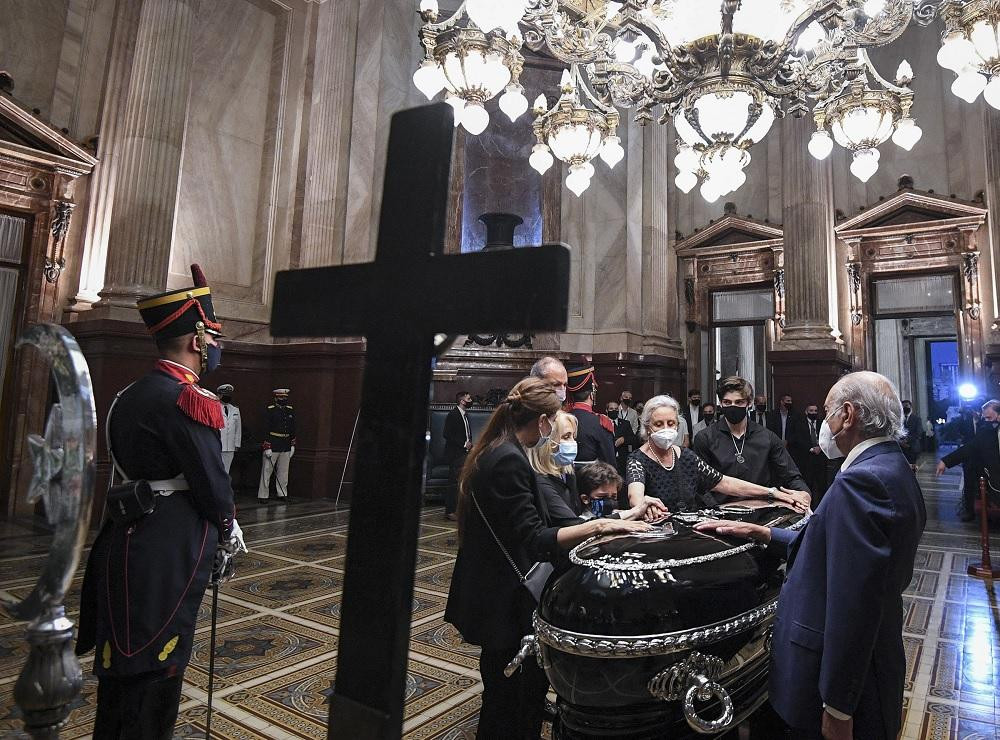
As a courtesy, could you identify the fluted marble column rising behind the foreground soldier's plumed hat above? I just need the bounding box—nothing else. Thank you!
[100,0,200,306]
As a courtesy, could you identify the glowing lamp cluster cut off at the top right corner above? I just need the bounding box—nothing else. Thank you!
[937,0,1000,109]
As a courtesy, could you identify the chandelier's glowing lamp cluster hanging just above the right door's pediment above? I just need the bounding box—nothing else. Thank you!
[809,49,923,182]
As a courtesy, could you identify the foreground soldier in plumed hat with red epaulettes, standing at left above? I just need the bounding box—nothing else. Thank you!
[76,265,242,739]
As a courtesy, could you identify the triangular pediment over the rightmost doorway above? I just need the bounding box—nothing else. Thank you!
[836,188,987,240]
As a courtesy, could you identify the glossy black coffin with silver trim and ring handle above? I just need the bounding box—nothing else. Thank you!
[534,506,801,738]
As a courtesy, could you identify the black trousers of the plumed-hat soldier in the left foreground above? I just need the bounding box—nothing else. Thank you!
[94,669,184,740]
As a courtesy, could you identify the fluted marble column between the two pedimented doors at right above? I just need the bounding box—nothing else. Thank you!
[781,116,835,349]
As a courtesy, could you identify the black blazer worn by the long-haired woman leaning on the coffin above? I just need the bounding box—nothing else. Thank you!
[444,442,559,650]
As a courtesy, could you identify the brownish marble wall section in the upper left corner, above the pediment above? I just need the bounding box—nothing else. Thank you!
[0,0,69,126]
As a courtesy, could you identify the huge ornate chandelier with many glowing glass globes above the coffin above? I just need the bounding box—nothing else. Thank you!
[414,0,952,202]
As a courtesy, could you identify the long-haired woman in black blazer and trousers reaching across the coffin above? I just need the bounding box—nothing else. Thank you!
[445,378,649,740]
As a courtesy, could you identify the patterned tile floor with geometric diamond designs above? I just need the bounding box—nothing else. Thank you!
[0,454,1000,740]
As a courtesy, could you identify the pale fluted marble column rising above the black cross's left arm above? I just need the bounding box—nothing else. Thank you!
[298,0,360,267]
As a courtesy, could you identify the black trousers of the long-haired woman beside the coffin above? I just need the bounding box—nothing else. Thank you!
[476,647,549,740]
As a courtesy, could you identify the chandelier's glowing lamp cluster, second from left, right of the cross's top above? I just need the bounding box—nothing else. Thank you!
[528,65,625,197]
